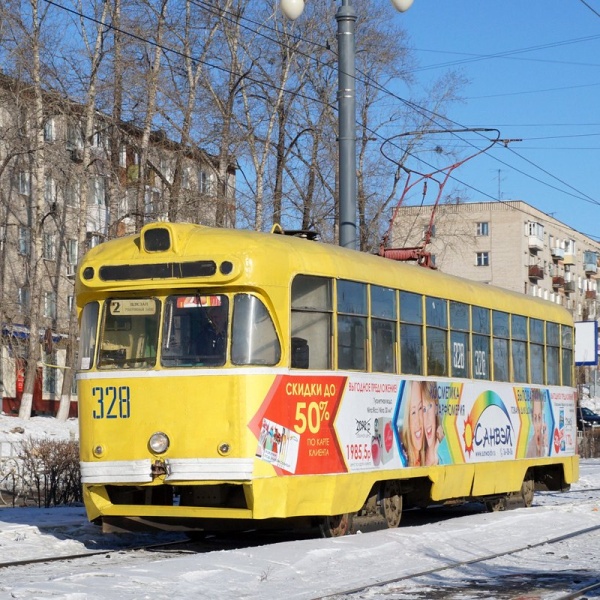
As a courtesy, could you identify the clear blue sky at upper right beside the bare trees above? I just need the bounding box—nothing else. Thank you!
[390,0,600,239]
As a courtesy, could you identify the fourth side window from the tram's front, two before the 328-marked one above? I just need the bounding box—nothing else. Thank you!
[400,292,423,375]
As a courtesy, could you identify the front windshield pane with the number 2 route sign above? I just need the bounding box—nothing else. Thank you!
[98,298,160,369]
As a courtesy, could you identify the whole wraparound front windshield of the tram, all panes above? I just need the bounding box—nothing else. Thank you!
[79,293,281,370]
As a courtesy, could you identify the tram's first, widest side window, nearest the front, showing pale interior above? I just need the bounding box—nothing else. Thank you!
[291,275,333,369]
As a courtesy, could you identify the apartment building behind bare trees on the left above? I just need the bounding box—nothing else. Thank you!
[0,75,236,413]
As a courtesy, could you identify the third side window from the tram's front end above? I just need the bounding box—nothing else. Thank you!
[371,285,398,373]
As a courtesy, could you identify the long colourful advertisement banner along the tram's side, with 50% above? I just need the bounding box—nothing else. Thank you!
[249,374,576,475]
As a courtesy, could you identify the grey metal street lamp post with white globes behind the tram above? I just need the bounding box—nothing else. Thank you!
[281,0,413,249]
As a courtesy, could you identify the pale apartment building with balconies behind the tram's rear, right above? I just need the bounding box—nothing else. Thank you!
[390,201,600,320]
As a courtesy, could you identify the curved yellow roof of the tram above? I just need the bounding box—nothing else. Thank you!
[76,223,571,322]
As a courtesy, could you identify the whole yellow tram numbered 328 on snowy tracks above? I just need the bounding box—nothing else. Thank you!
[76,223,579,535]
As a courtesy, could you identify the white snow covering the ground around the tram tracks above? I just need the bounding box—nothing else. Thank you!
[0,417,600,600]
